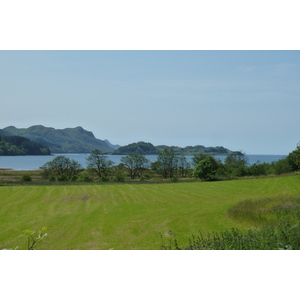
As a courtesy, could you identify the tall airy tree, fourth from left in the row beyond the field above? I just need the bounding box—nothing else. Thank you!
[157,149,178,178]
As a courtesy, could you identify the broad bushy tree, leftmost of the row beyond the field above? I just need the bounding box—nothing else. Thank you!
[41,155,82,180]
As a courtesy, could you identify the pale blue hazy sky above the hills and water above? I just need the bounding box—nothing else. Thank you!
[0,51,300,154]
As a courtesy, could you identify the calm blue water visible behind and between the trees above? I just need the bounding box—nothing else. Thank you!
[0,153,286,170]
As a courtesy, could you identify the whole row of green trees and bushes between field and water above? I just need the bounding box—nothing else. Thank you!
[41,146,300,182]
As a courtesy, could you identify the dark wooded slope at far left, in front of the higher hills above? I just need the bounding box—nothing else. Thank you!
[0,134,50,156]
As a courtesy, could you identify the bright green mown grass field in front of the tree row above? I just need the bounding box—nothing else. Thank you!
[0,176,300,249]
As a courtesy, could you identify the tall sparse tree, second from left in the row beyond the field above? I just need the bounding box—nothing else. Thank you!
[86,149,113,178]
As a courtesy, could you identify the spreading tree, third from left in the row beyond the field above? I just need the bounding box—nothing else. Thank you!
[121,154,149,179]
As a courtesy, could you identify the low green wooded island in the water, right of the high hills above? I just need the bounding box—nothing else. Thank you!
[112,142,231,155]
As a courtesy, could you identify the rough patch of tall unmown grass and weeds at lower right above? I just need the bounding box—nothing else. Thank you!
[161,196,300,250]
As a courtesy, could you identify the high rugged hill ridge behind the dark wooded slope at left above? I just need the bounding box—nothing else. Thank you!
[0,125,118,153]
